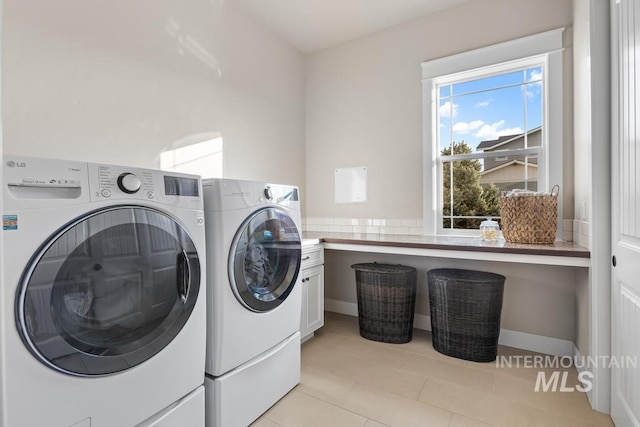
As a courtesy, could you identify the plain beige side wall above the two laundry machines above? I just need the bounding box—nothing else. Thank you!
[3,0,305,195]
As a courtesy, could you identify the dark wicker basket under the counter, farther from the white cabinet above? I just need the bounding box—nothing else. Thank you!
[427,268,505,362]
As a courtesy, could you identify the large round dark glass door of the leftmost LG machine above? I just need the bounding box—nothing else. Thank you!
[16,206,200,376]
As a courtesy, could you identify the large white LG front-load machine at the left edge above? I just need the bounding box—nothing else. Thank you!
[0,156,206,427]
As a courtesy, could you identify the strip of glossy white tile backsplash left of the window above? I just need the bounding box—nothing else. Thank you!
[302,217,424,236]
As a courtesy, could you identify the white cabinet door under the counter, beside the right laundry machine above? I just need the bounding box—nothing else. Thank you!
[300,265,324,339]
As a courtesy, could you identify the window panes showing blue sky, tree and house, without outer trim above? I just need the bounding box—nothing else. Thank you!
[435,58,547,230]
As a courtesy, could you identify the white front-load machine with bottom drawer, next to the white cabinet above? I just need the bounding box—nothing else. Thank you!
[203,179,302,427]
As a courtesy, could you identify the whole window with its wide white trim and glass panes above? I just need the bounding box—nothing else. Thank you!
[422,30,562,235]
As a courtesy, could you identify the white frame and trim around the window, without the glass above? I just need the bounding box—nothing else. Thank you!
[422,28,564,239]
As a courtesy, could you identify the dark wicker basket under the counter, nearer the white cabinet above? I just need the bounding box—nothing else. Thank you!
[351,263,417,344]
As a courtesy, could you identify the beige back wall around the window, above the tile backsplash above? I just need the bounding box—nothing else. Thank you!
[306,0,573,218]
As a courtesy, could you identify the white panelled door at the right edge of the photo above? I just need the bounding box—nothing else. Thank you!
[611,0,640,427]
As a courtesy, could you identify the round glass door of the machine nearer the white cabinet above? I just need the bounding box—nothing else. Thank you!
[229,208,302,312]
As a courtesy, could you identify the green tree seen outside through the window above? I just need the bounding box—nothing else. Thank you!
[442,141,500,228]
